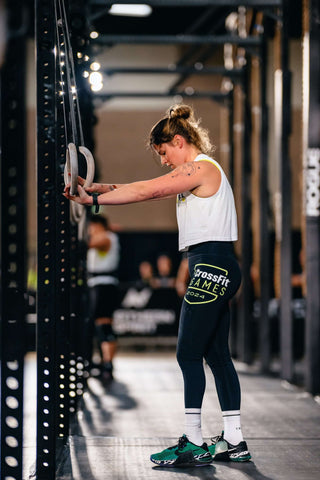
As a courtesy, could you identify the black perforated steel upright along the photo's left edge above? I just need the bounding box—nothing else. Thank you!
[0,0,26,480]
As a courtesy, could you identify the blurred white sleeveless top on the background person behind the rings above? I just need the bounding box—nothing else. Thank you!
[87,232,120,287]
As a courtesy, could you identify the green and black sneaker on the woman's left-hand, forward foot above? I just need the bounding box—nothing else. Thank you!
[150,435,213,467]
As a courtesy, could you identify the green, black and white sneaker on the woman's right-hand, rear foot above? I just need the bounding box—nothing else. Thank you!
[208,432,251,462]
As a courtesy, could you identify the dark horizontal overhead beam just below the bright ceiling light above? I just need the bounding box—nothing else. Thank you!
[94,34,261,47]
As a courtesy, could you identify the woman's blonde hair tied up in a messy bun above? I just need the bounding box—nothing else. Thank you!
[149,104,214,155]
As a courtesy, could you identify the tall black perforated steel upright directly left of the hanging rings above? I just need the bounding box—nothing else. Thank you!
[35,0,70,480]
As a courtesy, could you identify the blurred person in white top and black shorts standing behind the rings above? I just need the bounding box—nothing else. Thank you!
[87,215,120,380]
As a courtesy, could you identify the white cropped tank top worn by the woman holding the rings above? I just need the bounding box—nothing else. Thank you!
[177,154,238,251]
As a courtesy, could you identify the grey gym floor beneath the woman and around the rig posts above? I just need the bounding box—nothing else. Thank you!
[24,351,320,480]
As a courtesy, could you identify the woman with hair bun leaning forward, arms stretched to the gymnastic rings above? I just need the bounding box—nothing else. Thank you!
[65,105,251,467]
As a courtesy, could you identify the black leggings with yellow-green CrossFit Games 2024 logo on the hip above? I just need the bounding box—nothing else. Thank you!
[177,242,241,411]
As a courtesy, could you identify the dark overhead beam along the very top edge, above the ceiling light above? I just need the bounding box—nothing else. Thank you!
[89,0,282,7]
